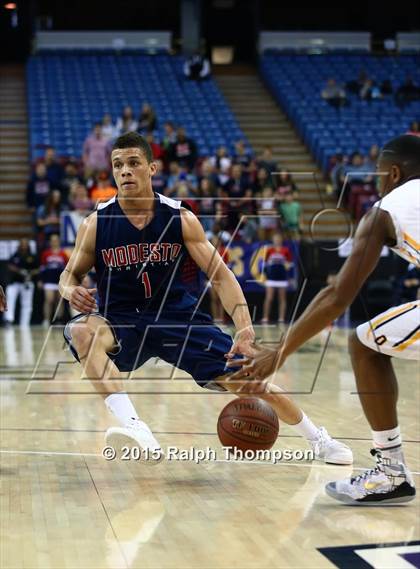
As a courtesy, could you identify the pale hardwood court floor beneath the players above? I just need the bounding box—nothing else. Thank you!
[0,327,420,569]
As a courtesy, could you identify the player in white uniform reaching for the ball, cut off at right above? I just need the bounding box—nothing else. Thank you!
[232,135,420,505]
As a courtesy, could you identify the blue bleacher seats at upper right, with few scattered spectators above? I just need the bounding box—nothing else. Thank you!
[260,53,420,171]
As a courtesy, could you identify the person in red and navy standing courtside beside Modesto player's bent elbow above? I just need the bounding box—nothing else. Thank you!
[39,234,68,326]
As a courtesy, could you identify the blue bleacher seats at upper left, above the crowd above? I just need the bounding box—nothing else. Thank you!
[27,54,245,160]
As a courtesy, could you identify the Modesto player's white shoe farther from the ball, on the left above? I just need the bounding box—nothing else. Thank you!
[105,421,165,465]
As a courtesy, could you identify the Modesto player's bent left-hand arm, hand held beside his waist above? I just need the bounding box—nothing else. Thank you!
[59,213,97,313]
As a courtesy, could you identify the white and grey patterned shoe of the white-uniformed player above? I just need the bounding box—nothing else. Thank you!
[325,449,416,506]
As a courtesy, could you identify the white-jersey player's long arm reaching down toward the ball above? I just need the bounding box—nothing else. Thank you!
[233,208,396,379]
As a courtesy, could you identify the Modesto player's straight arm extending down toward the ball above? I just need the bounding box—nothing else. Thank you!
[181,208,255,353]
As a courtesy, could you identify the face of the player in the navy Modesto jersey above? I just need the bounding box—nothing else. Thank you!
[111,148,156,197]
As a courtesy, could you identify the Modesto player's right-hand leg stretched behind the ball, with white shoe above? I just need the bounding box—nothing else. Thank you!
[215,375,353,465]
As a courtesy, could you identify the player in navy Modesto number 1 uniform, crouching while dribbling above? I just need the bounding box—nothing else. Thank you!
[60,132,353,464]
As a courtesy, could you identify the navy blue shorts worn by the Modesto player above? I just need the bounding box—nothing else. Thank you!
[64,310,238,391]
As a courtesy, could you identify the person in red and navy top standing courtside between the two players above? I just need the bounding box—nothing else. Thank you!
[261,233,292,324]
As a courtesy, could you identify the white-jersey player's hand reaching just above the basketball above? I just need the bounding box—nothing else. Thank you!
[227,344,284,382]
